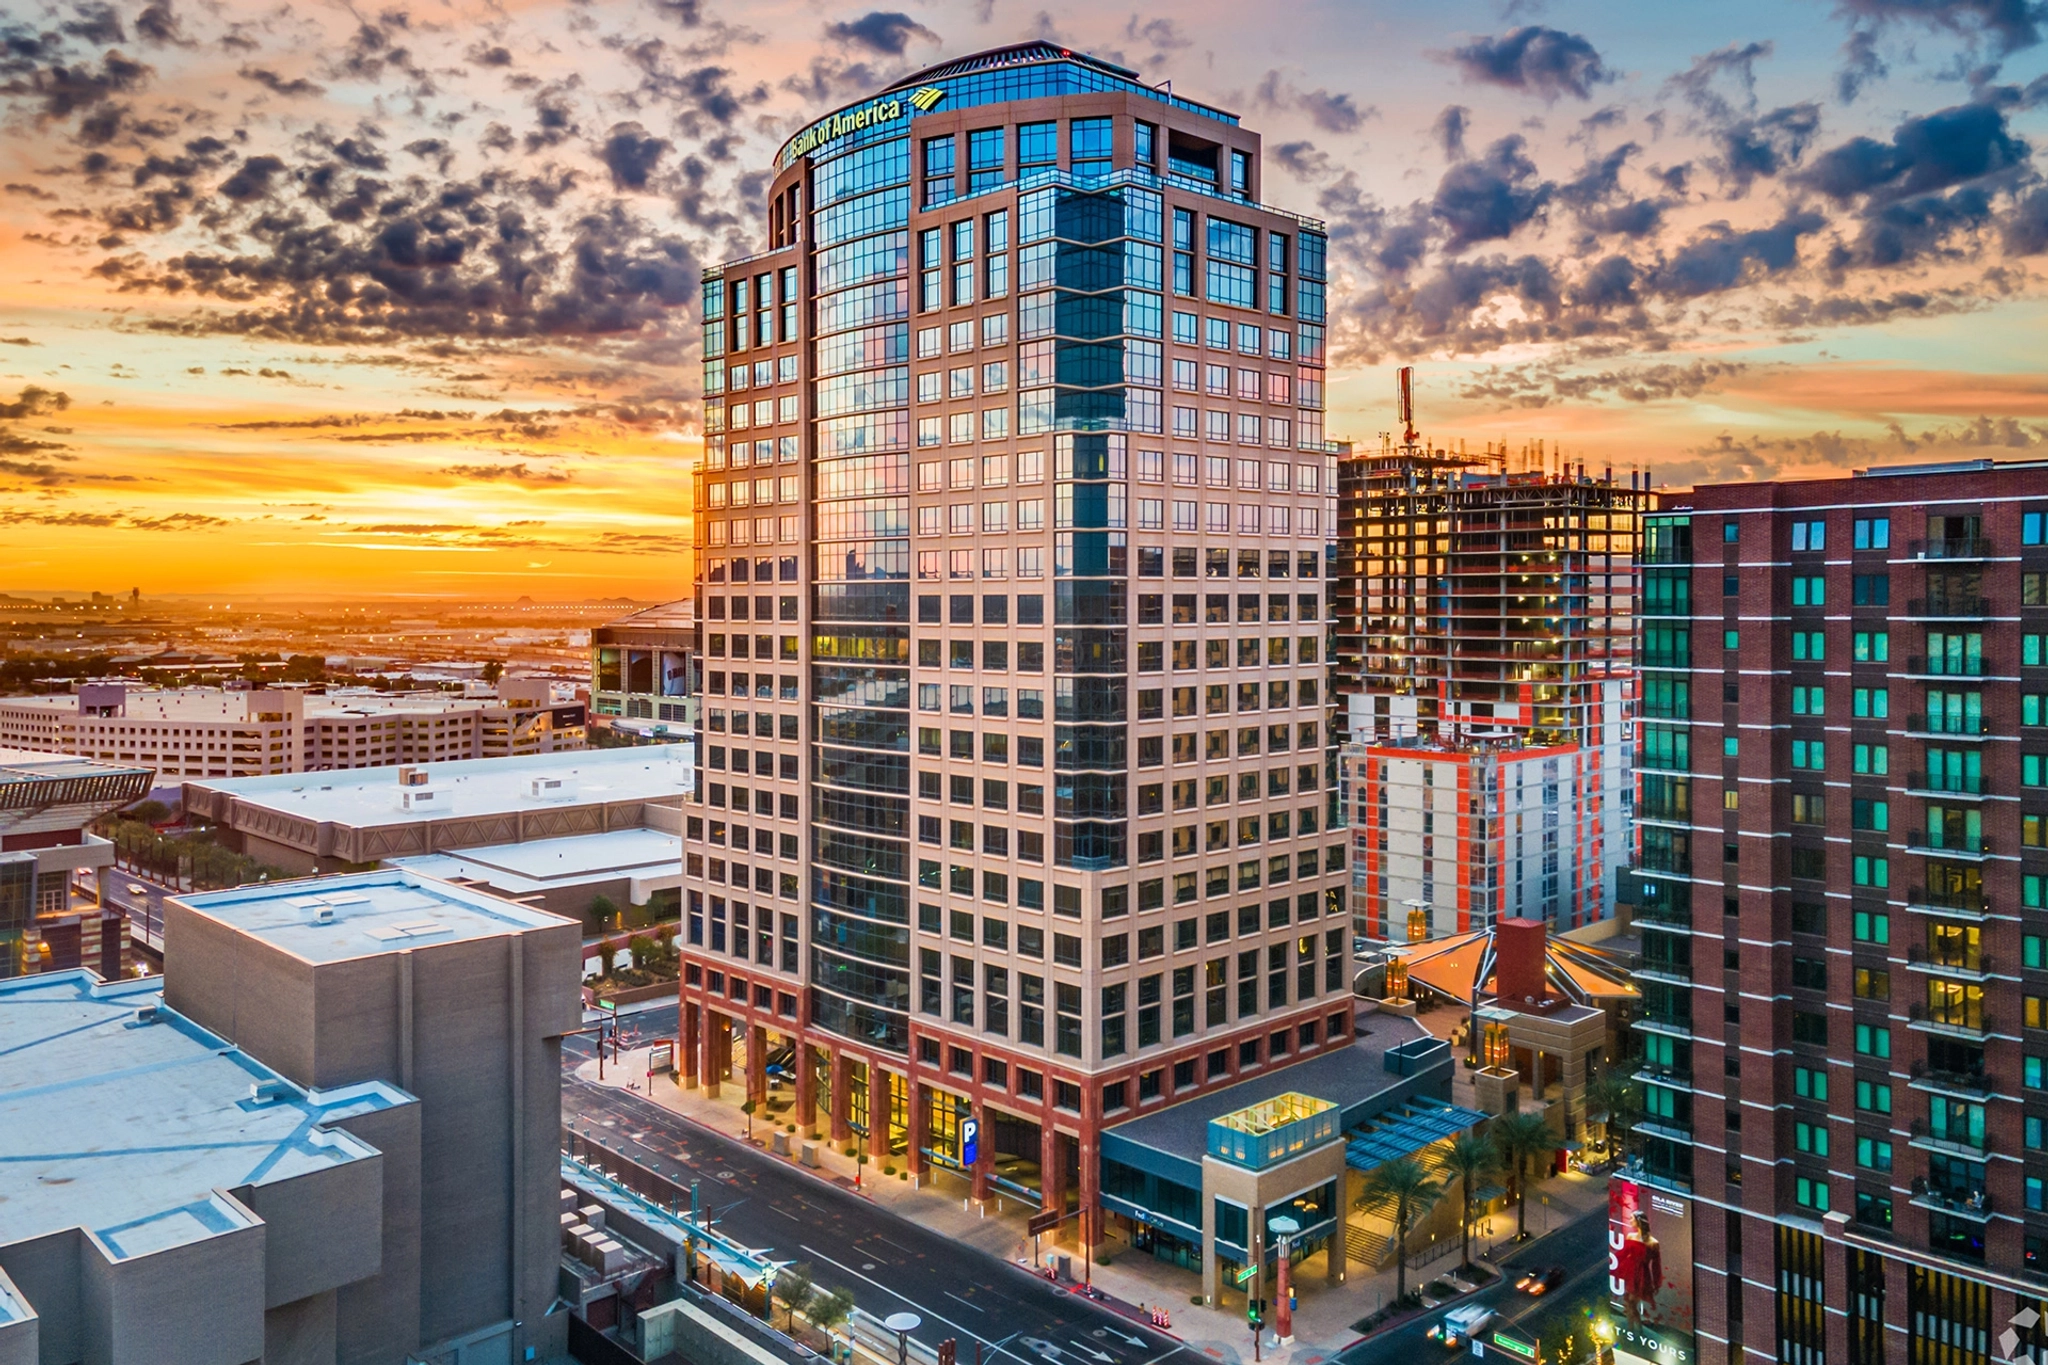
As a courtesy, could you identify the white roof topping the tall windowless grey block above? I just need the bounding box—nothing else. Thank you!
[178,868,569,962]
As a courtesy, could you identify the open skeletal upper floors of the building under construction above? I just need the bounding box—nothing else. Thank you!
[1335,440,1649,747]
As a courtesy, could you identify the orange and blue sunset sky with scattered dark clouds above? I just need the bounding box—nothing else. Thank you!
[0,0,2048,600]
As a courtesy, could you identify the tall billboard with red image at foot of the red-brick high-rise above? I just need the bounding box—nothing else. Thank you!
[1608,1177,1696,1365]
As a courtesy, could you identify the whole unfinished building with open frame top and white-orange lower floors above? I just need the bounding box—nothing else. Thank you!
[1335,370,1649,939]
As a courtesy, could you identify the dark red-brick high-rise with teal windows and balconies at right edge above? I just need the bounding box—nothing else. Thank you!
[1618,460,2048,1365]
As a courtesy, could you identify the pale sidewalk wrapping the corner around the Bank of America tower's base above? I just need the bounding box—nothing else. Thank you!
[575,1062,1608,1365]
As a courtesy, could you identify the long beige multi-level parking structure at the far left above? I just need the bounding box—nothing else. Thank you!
[0,677,584,786]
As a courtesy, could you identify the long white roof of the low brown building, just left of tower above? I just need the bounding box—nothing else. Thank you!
[186,745,696,827]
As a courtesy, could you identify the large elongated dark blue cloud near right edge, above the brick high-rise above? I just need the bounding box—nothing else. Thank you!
[1800,102,2032,205]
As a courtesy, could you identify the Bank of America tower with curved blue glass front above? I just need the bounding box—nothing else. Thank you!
[682,43,1350,1232]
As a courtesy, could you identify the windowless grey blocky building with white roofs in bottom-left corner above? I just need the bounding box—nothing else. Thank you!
[0,872,580,1365]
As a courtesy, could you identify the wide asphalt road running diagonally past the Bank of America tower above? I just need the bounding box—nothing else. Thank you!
[561,1039,1186,1365]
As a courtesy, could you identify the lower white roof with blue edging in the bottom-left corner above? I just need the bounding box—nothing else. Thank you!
[0,972,412,1268]
